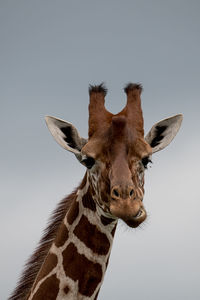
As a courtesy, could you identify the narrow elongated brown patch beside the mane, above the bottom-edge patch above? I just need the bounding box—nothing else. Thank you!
[33,253,58,290]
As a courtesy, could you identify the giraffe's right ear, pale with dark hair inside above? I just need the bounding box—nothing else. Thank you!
[145,114,183,153]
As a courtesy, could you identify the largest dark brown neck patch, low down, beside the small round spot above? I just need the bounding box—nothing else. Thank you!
[63,243,102,297]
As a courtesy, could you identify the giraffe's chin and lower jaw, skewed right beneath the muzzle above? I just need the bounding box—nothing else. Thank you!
[112,207,147,228]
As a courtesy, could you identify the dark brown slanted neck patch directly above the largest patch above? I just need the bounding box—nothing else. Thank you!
[74,216,110,255]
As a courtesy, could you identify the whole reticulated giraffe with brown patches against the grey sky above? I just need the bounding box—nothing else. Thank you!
[9,83,183,300]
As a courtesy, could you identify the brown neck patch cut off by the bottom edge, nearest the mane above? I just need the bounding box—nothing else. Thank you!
[32,275,59,300]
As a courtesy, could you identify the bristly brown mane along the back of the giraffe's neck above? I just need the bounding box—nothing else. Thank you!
[8,186,79,300]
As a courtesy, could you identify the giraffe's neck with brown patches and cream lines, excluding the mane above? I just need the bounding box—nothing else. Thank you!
[27,176,117,300]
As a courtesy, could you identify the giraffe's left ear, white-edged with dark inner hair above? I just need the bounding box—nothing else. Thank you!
[45,116,87,161]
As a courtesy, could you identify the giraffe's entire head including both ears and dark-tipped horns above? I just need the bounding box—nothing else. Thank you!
[46,83,182,227]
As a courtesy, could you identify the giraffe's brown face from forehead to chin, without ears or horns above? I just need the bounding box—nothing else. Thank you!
[81,116,152,227]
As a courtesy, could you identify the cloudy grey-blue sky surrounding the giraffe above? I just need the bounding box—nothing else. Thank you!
[0,0,200,300]
